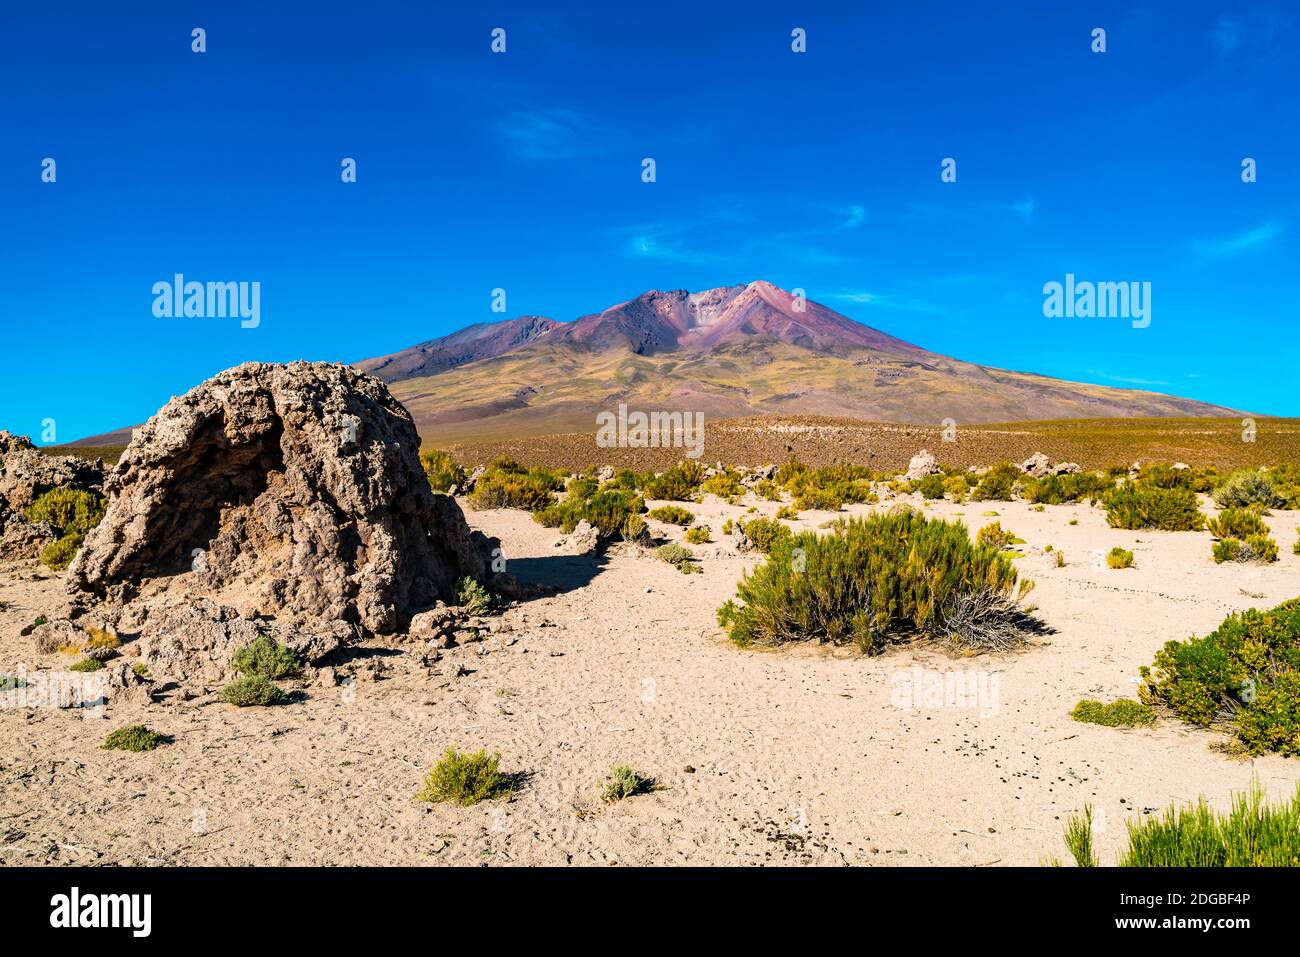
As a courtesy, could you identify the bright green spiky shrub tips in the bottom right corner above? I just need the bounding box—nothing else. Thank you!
[1066,781,1300,867]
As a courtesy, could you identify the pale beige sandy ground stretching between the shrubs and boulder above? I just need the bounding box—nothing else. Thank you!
[0,499,1300,866]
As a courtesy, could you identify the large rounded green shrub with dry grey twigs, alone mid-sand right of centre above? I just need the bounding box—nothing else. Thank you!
[718,510,1017,653]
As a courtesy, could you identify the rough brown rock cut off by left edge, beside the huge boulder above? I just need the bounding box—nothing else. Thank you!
[0,432,104,560]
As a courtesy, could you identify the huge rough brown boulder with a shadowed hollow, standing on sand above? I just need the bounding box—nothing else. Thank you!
[68,361,497,634]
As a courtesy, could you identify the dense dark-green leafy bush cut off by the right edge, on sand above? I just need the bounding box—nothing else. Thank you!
[1139,598,1300,754]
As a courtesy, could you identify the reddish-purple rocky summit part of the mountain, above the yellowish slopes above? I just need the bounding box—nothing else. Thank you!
[551,281,931,356]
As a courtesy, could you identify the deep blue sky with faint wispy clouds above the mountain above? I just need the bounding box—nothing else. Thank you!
[0,0,1300,441]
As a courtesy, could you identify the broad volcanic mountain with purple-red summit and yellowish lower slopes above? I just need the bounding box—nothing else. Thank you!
[359,282,1238,442]
